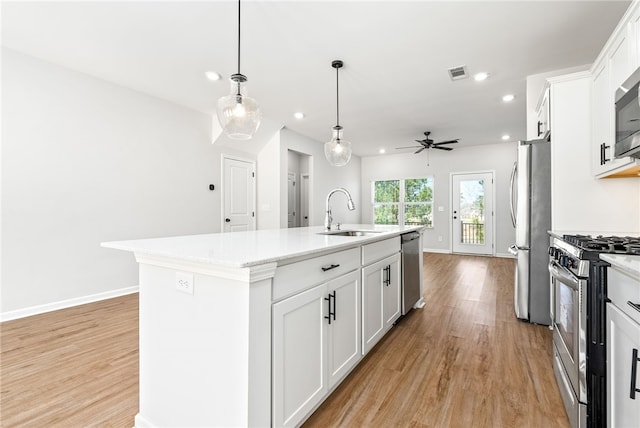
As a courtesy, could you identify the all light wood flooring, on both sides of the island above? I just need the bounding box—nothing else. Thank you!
[0,254,569,428]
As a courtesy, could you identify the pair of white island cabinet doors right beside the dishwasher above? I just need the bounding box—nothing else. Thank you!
[362,253,401,354]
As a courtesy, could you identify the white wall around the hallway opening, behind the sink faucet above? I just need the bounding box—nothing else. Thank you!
[280,128,362,227]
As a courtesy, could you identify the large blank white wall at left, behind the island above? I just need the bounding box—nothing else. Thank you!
[0,49,242,319]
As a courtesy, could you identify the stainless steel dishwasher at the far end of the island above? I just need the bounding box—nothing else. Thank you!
[400,232,422,315]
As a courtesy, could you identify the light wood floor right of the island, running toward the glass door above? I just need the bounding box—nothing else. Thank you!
[305,253,569,428]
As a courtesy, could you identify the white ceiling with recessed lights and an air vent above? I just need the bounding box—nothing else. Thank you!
[2,0,629,156]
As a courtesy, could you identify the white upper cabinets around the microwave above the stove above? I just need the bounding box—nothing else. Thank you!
[591,5,640,178]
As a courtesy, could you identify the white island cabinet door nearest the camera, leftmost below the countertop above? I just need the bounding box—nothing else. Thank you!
[273,284,329,426]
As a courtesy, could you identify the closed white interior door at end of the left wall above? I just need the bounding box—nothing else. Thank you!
[222,157,256,232]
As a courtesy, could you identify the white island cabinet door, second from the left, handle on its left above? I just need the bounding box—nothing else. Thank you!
[327,270,362,388]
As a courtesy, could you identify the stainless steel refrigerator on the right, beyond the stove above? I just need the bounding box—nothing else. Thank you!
[509,136,551,325]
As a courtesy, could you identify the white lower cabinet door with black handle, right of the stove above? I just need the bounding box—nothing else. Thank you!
[607,304,640,427]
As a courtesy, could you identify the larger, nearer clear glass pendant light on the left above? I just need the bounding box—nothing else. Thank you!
[217,0,262,140]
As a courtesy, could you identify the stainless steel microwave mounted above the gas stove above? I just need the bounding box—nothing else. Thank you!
[613,68,640,158]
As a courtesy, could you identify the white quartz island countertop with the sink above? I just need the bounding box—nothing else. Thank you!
[101,224,422,268]
